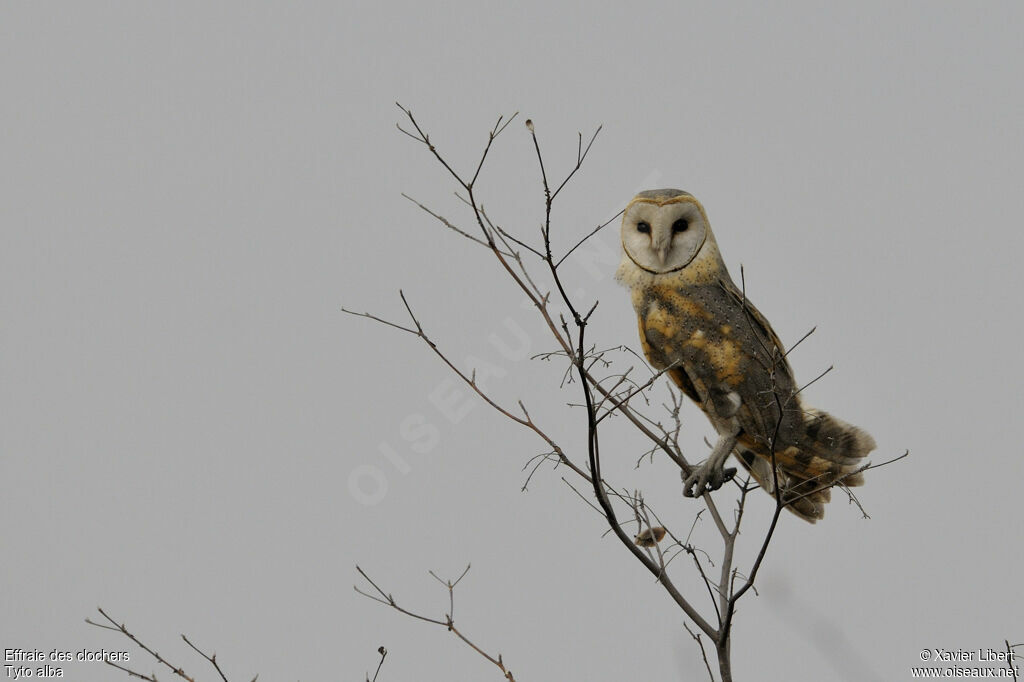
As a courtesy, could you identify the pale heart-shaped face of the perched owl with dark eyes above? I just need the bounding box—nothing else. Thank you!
[623,195,708,274]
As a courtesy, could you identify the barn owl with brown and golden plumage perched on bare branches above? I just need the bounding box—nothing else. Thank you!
[615,189,874,523]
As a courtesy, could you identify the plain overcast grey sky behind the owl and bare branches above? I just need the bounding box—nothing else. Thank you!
[0,2,1024,682]
